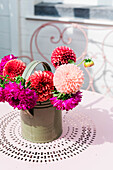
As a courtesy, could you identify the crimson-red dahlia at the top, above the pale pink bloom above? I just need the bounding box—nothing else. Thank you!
[51,46,76,68]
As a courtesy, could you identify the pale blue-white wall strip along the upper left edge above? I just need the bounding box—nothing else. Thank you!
[0,0,20,58]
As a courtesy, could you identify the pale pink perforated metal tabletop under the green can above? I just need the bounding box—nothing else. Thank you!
[0,91,113,170]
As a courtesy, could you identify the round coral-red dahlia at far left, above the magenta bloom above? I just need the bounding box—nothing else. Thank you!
[3,59,26,79]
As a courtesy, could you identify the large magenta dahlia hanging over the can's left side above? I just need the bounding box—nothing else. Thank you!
[4,82,38,110]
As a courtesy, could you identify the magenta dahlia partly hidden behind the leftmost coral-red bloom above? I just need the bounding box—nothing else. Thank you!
[0,54,17,75]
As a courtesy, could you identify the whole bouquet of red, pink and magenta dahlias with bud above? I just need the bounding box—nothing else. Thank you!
[0,46,94,111]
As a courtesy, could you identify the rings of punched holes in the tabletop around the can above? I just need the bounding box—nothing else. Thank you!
[0,110,96,163]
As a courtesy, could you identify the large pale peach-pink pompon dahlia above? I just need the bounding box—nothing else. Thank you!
[53,64,84,94]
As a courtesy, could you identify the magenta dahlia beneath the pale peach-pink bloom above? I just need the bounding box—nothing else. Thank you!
[50,91,82,111]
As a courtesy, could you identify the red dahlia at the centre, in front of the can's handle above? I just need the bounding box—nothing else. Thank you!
[27,71,54,102]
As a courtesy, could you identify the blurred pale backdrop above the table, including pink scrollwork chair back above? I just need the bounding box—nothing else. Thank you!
[0,0,113,97]
